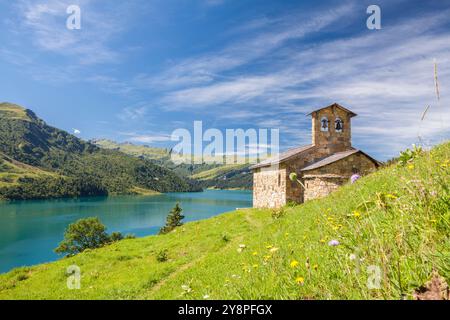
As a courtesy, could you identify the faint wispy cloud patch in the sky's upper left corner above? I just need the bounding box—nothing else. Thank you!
[15,0,121,65]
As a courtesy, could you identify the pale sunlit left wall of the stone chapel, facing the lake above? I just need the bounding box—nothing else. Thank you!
[253,166,287,208]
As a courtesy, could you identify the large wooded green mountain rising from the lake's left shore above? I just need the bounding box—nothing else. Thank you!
[0,103,201,199]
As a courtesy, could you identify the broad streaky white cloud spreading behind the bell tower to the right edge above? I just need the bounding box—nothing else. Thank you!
[151,3,450,156]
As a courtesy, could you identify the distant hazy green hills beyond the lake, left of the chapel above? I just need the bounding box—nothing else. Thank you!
[91,139,253,189]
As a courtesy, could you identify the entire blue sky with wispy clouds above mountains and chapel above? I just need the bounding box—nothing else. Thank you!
[0,0,450,160]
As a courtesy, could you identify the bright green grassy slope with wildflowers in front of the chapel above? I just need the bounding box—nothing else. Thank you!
[0,143,450,299]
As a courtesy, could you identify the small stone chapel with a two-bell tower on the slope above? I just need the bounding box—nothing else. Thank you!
[250,103,380,208]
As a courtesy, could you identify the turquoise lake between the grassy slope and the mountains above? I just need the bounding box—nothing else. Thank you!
[0,190,252,273]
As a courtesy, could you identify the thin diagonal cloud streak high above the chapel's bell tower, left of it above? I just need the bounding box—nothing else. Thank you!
[143,5,352,87]
